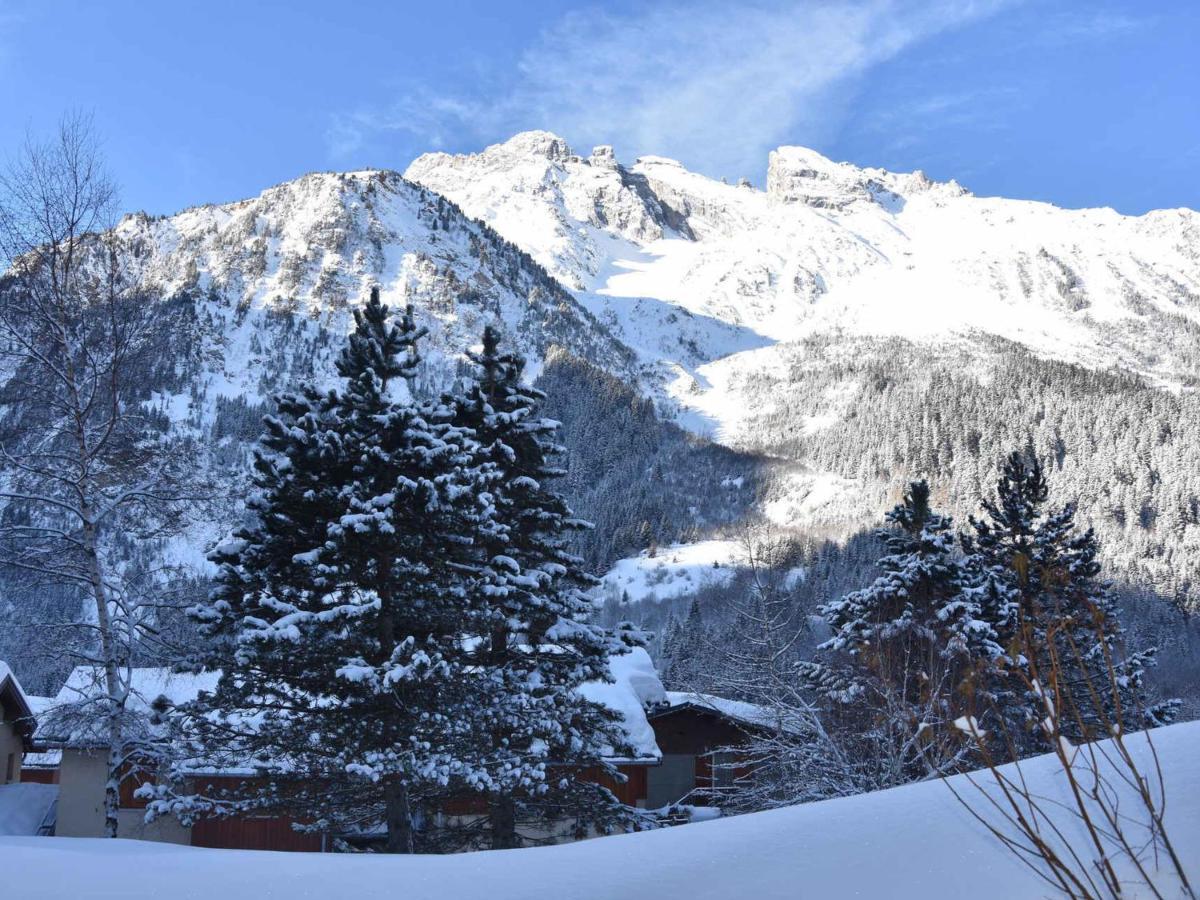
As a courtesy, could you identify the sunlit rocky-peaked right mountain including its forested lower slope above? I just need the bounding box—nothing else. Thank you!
[406,132,1200,602]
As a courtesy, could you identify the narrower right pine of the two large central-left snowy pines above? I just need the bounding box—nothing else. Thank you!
[455,328,631,848]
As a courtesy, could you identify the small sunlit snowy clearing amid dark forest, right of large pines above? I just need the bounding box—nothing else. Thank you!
[599,540,745,604]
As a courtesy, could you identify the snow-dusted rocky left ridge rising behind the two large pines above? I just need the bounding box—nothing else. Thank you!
[118,172,636,422]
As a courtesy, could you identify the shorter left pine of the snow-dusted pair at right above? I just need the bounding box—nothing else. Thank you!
[804,481,1001,784]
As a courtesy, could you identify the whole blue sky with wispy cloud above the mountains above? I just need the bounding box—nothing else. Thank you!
[0,0,1200,214]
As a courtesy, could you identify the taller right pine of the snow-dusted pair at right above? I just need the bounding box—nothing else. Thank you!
[964,451,1177,748]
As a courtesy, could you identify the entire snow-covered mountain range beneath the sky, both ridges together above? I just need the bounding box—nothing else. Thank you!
[7,132,1200,691]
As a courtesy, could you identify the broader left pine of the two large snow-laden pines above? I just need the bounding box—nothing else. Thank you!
[175,289,487,852]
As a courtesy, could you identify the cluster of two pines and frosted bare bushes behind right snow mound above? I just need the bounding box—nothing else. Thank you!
[660,451,1178,810]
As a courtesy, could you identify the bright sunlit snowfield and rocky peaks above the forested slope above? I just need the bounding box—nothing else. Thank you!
[406,132,1200,439]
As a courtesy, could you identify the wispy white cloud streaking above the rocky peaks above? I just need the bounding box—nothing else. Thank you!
[328,0,1010,175]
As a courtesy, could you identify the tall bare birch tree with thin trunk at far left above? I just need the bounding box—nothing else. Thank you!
[0,115,195,836]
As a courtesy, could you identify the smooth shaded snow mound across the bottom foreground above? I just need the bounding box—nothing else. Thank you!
[0,722,1200,900]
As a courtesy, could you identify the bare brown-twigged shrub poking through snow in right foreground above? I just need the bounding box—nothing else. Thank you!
[946,606,1195,900]
